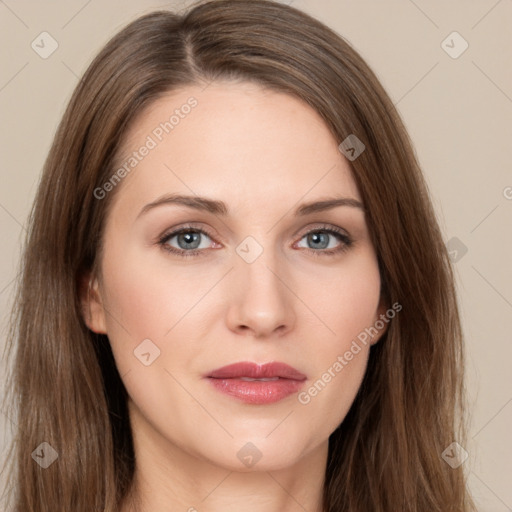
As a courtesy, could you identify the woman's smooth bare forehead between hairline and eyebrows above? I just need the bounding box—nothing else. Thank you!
[110,82,360,215]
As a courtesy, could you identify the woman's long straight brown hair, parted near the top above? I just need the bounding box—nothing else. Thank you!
[3,0,475,512]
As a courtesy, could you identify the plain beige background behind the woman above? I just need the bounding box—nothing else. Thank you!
[0,0,512,512]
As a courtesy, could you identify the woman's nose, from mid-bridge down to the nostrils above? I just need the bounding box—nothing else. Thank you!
[227,250,298,339]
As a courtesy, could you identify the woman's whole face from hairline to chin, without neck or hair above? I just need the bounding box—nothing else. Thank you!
[85,82,385,471]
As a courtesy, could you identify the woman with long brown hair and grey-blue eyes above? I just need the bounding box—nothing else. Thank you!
[2,0,474,512]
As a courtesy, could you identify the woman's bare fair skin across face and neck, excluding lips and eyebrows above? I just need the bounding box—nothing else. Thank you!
[84,82,387,512]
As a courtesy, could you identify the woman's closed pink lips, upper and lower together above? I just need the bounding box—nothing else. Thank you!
[206,362,307,404]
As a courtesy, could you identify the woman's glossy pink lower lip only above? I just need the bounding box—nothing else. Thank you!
[208,377,304,404]
